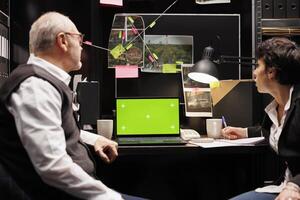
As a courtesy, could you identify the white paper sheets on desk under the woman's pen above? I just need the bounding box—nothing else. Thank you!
[189,137,264,148]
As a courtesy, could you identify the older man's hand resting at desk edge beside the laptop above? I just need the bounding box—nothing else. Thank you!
[94,136,118,163]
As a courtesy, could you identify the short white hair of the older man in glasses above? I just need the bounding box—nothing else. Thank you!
[29,12,75,53]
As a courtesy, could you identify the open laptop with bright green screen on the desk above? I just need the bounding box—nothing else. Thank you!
[116,98,186,145]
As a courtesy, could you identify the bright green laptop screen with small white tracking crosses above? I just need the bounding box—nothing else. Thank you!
[116,98,179,135]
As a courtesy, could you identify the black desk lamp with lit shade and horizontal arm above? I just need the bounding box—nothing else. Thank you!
[188,46,256,84]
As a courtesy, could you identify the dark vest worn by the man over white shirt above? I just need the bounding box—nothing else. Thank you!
[0,65,95,199]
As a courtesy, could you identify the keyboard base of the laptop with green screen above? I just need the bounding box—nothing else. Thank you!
[117,137,185,145]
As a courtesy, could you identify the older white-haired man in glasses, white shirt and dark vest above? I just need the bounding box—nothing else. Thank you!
[0,12,145,200]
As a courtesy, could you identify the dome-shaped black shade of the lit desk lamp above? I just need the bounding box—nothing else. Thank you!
[188,58,218,84]
